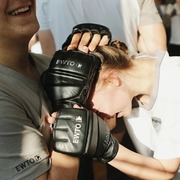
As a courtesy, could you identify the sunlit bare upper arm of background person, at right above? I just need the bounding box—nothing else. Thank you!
[138,23,167,52]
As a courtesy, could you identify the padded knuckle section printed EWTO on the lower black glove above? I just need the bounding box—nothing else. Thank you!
[53,108,97,155]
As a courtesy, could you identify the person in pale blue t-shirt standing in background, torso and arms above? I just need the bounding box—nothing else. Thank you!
[37,0,166,56]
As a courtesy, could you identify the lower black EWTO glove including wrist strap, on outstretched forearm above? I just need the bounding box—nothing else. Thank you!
[53,108,119,163]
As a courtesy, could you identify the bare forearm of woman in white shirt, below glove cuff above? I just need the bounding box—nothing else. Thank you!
[109,145,180,180]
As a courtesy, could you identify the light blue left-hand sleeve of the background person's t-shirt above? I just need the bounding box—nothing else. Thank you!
[36,0,49,30]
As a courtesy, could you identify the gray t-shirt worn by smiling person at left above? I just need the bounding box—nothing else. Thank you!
[0,54,51,180]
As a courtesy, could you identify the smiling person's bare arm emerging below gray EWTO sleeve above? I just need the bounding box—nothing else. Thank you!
[36,151,79,180]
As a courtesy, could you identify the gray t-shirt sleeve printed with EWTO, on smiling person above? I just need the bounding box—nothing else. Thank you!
[0,91,50,180]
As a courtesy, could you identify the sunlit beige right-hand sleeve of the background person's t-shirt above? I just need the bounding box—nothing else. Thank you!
[140,0,162,26]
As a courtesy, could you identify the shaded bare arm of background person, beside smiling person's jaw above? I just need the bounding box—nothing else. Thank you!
[38,30,56,57]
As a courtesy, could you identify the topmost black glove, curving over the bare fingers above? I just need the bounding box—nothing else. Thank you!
[62,23,112,49]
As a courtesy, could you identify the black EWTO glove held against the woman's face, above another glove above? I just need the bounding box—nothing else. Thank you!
[41,50,101,111]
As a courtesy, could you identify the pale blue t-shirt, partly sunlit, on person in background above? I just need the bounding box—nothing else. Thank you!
[36,0,162,54]
